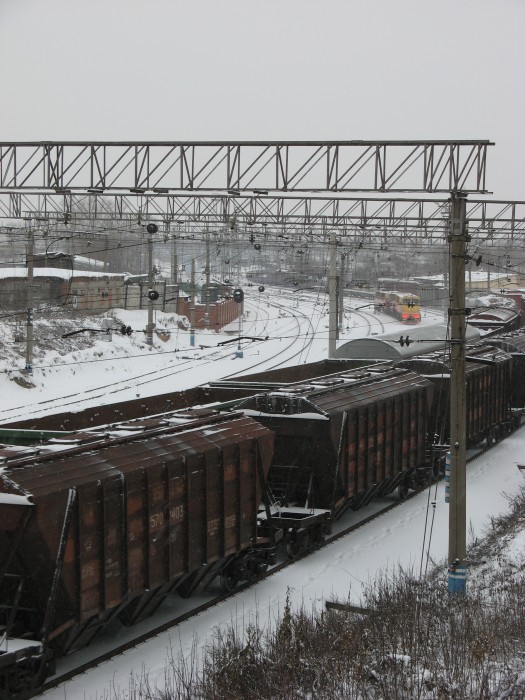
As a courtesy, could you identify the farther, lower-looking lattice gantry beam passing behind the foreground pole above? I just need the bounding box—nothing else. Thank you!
[0,193,525,242]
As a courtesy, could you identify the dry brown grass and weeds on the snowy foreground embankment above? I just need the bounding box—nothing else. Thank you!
[111,486,525,700]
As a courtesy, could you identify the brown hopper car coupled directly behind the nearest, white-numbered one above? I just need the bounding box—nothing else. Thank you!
[237,366,432,556]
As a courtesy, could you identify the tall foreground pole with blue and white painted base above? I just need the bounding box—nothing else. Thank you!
[448,192,469,594]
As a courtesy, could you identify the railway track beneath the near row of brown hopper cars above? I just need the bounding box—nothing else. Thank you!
[37,426,520,698]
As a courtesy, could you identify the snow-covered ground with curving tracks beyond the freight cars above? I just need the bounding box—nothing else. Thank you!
[0,290,442,423]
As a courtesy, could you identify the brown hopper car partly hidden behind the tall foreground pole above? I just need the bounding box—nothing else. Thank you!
[397,342,513,447]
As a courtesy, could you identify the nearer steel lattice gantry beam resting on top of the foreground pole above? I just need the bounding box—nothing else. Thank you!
[0,141,493,194]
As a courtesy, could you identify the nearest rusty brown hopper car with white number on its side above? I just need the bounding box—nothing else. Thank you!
[0,409,275,698]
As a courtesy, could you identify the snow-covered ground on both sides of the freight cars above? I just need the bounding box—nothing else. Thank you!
[0,292,525,700]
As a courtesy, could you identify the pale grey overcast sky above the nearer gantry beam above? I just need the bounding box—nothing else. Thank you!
[0,0,525,200]
